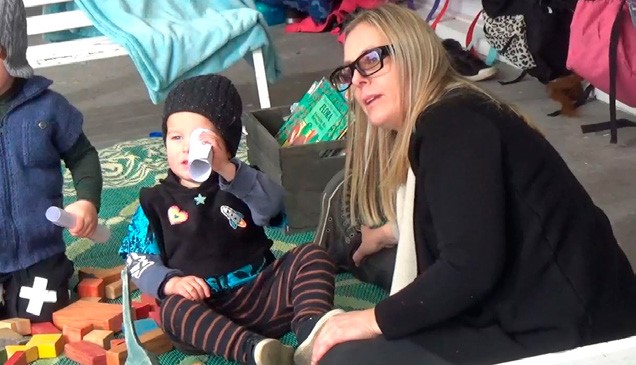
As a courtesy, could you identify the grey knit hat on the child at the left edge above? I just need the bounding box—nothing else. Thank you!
[0,0,33,78]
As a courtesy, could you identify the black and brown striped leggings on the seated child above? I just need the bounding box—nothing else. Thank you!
[161,244,336,363]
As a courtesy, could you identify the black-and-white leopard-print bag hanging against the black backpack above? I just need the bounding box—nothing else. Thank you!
[483,13,537,70]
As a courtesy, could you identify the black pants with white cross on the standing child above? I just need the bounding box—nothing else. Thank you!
[0,252,74,322]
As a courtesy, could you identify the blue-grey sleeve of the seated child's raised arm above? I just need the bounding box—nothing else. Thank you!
[219,159,285,226]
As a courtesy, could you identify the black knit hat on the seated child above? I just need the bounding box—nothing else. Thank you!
[161,74,243,156]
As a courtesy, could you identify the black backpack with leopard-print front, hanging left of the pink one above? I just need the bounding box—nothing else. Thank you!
[482,0,576,84]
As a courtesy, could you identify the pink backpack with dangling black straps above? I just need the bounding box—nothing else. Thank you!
[567,0,636,143]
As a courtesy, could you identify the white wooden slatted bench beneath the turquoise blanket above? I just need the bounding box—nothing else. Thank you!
[24,0,271,108]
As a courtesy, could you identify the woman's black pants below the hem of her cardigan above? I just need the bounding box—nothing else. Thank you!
[319,323,536,365]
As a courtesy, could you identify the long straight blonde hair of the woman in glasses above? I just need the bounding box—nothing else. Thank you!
[344,4,504,226]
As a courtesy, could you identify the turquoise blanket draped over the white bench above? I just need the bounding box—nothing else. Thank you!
[47,0,280,104]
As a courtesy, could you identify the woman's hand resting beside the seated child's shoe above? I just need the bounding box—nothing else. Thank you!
[311,308,382,365]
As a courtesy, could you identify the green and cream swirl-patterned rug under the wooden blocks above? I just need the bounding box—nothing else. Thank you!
[34,138,386,365]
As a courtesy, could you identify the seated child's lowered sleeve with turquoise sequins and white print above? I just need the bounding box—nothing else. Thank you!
[119,207,183,298]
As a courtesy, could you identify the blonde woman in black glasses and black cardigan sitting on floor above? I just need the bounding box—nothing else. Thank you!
[311,5,636,365]
